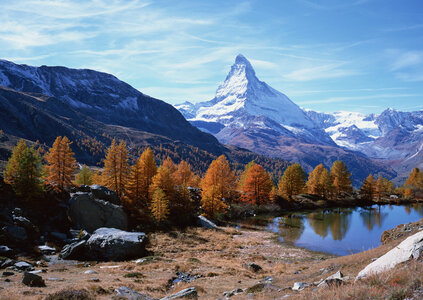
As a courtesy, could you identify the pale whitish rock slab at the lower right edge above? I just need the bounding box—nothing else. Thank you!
[357,230,423,279]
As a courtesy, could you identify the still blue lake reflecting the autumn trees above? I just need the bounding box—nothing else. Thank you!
[267,203,423,255]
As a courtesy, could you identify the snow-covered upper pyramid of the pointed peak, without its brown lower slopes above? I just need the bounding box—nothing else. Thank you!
[175,54,333,144]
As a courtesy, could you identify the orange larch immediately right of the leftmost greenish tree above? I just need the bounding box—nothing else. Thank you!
[45,136,77,191]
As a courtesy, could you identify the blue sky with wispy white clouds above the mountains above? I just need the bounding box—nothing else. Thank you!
[0,0,423,113]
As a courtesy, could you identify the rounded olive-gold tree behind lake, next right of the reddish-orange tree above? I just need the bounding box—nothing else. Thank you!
[278,163,306,200]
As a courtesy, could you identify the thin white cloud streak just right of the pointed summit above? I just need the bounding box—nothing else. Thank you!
[284,63,359,81]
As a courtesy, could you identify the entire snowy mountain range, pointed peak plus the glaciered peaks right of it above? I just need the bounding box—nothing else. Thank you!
[175,55,423,183]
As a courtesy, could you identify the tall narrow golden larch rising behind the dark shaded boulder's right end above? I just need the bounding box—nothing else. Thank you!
[103,139,131,197]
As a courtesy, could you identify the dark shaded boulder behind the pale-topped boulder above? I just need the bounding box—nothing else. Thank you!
[68,193,128,233]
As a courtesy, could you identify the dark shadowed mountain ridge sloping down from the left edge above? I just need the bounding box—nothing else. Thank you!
[0,60,287,176]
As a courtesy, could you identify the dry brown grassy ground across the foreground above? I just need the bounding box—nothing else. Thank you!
[0,221,423,299]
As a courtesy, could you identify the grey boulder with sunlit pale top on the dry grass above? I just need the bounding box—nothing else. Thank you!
[86,228,147,261]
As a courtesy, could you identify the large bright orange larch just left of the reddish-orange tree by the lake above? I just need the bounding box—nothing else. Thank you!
[200,155,236,218]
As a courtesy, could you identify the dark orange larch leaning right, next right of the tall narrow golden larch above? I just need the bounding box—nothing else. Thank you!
[125,148,157,207]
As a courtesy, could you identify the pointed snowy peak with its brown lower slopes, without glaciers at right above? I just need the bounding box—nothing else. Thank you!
[175,55,396,184]
